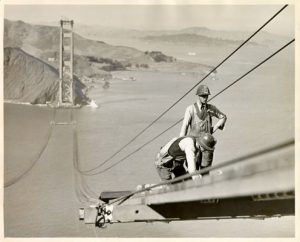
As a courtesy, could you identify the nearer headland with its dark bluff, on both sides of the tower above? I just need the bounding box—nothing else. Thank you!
[4,19,216,103]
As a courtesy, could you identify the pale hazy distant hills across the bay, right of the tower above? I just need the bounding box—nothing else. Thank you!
[72,24,290,66]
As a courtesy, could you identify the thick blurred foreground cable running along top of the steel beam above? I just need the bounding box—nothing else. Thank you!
[108,140,295,205]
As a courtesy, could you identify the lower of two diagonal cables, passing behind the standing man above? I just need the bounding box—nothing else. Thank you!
[79,39,295,176]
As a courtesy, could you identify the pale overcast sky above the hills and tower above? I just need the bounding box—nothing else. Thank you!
[4,5,294,36]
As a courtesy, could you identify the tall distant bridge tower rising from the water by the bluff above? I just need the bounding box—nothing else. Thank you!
[59,20,75,107]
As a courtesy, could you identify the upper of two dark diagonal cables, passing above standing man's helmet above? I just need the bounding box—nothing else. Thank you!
[80,4,288,174]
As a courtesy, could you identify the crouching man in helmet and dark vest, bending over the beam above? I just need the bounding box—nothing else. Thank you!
[155,133,217,180]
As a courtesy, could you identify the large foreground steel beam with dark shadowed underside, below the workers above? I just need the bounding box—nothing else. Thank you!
[102,146,295,222]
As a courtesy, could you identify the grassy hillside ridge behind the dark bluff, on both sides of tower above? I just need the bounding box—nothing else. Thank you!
[4,19,211,78]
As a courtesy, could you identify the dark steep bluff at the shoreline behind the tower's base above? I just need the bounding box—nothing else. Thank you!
[4,47,89,104]
